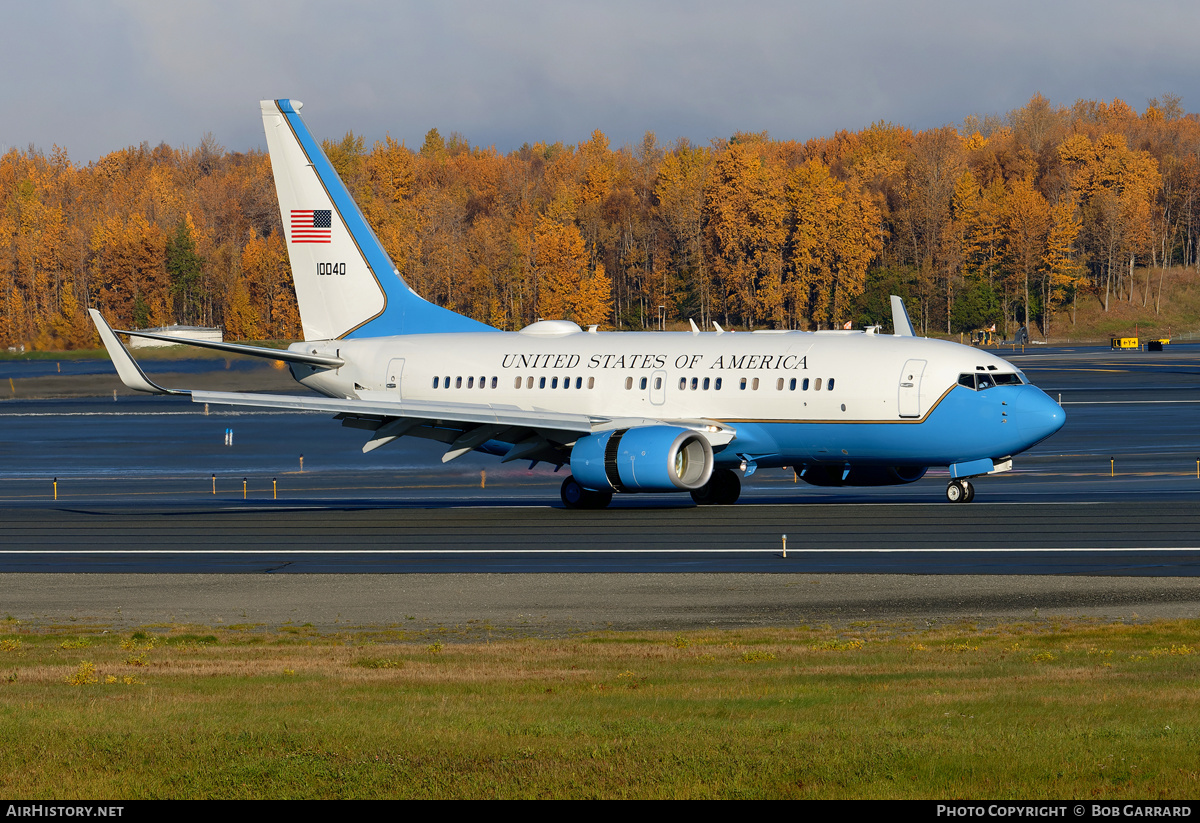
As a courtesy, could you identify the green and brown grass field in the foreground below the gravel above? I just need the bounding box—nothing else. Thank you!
[0,619,1200,799]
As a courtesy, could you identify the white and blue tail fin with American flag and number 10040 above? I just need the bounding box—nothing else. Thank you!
[262,100,492,340]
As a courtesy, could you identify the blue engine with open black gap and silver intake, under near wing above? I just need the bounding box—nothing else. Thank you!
[571,426,713,492]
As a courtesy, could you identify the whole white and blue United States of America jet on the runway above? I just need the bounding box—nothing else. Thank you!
[91,100,1064,509]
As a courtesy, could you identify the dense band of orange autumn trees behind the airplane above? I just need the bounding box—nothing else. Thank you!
[0,95,1200,347]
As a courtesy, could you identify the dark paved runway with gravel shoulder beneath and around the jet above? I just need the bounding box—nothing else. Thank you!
[0,346,1200,629]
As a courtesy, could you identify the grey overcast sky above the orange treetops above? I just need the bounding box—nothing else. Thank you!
[0,0,1200,163]
